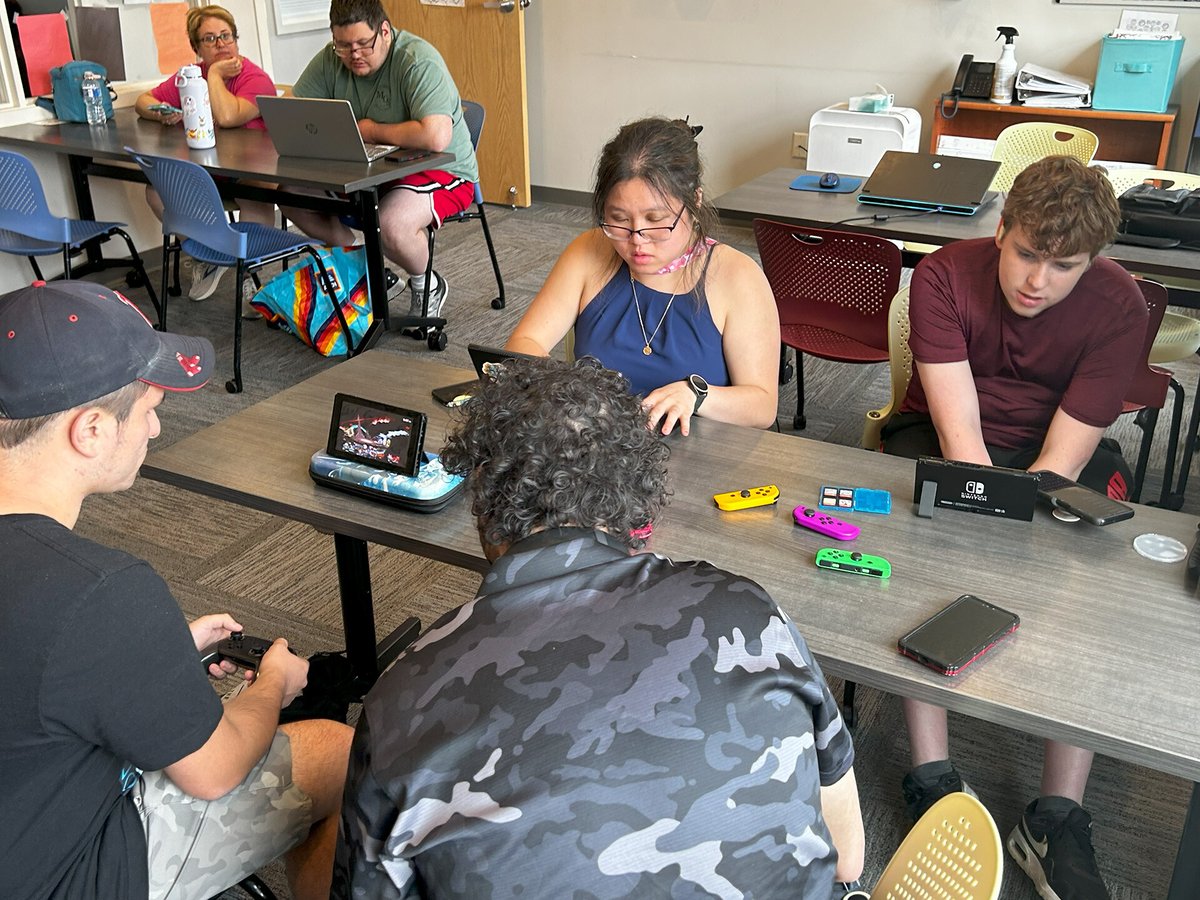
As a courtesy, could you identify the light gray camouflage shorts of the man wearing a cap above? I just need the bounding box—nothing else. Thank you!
[133,731,312,900]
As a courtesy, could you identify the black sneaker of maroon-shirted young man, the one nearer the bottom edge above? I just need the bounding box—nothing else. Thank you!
[1007,797,1109,900]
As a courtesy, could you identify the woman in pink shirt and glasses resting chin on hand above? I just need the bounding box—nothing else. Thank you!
[136,6,275,300]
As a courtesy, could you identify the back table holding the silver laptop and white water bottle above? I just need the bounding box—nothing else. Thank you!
[0,107,454,347]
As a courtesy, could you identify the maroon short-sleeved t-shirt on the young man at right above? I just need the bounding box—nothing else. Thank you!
[901,238,1147,449]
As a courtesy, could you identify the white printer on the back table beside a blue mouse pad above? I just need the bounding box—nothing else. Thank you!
[806,103,920,175]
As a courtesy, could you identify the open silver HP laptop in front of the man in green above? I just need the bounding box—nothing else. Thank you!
[257,95,400,162]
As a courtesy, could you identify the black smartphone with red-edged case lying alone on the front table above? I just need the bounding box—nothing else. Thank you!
[898,594,1021,676]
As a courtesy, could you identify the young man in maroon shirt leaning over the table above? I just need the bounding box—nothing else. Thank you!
[883,156,1147,900]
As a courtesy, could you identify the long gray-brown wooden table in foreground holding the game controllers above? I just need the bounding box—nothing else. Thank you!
[143,350,1200,900]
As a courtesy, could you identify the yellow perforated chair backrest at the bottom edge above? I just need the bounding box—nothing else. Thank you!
[871,793,1003,900]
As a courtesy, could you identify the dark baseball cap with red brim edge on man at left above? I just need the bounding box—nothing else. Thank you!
[0,281,215,419]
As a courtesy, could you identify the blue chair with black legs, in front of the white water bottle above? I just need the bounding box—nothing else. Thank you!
[125,146,354,394]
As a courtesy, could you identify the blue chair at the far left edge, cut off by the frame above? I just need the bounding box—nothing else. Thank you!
[0,150,162,317]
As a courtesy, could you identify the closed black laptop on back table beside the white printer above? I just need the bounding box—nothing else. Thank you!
[858,150,1000,216]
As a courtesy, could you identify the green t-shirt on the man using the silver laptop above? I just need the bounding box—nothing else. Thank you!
[292,31,479,181]
